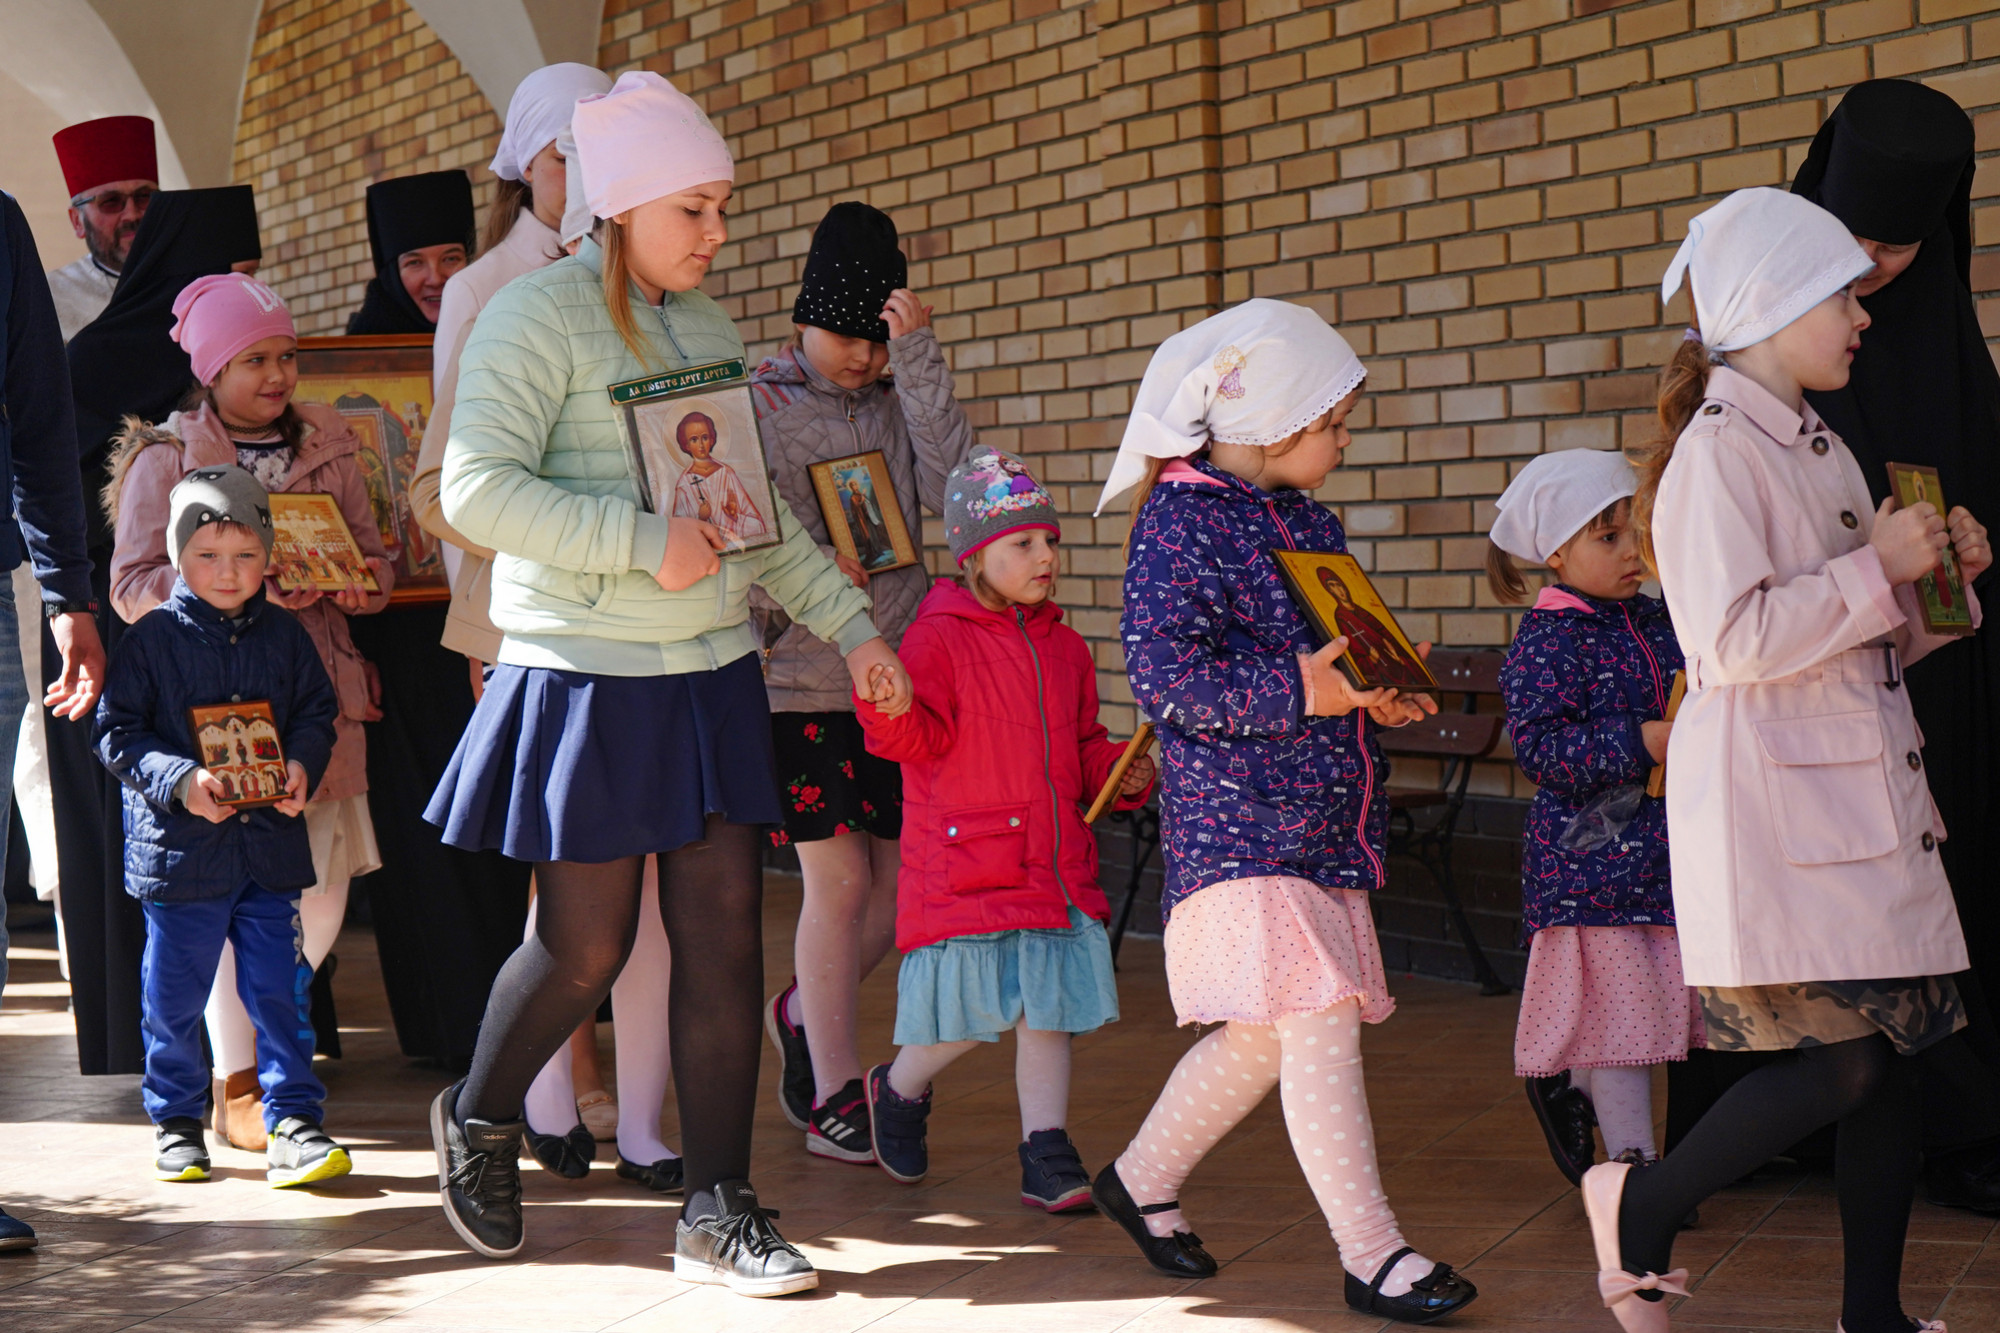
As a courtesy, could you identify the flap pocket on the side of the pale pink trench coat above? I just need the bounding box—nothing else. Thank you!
[1754,709,1898,865]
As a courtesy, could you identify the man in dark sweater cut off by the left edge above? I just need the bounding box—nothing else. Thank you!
[0,192,104,1251]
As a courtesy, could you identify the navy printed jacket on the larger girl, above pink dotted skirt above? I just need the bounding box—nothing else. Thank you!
[1120,456,1388,915]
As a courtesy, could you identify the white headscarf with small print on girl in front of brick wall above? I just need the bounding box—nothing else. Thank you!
[1096,298,1368,514]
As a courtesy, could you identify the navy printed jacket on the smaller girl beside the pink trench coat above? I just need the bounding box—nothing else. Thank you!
[1500,584,1682,935]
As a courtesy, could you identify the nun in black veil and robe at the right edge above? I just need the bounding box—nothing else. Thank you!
[1792,78,2000,1211]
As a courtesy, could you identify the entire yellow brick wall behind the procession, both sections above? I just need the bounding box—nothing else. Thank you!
[227,0,2000,793]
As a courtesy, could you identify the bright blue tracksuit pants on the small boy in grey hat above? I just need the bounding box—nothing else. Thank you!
[140,881,326,1129]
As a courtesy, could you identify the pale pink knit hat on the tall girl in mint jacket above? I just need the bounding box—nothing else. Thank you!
[570,70,736,218]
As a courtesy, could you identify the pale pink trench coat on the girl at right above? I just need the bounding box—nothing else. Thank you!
[1654,366,1978,987]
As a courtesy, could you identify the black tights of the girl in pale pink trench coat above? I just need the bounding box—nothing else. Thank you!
[1618,1035,1922,1333]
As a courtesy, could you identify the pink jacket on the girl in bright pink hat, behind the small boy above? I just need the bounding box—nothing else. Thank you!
[104,402,396,801]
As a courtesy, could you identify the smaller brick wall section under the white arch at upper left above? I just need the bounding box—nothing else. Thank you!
[236,0,500,334]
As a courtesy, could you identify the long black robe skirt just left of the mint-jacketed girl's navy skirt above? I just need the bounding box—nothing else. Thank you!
[346,602,528,1069]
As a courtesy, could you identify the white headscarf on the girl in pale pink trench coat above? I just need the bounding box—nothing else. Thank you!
[1660,186,1874,352]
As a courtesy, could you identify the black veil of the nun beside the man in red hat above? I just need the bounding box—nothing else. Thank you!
[70,186,264,546]
